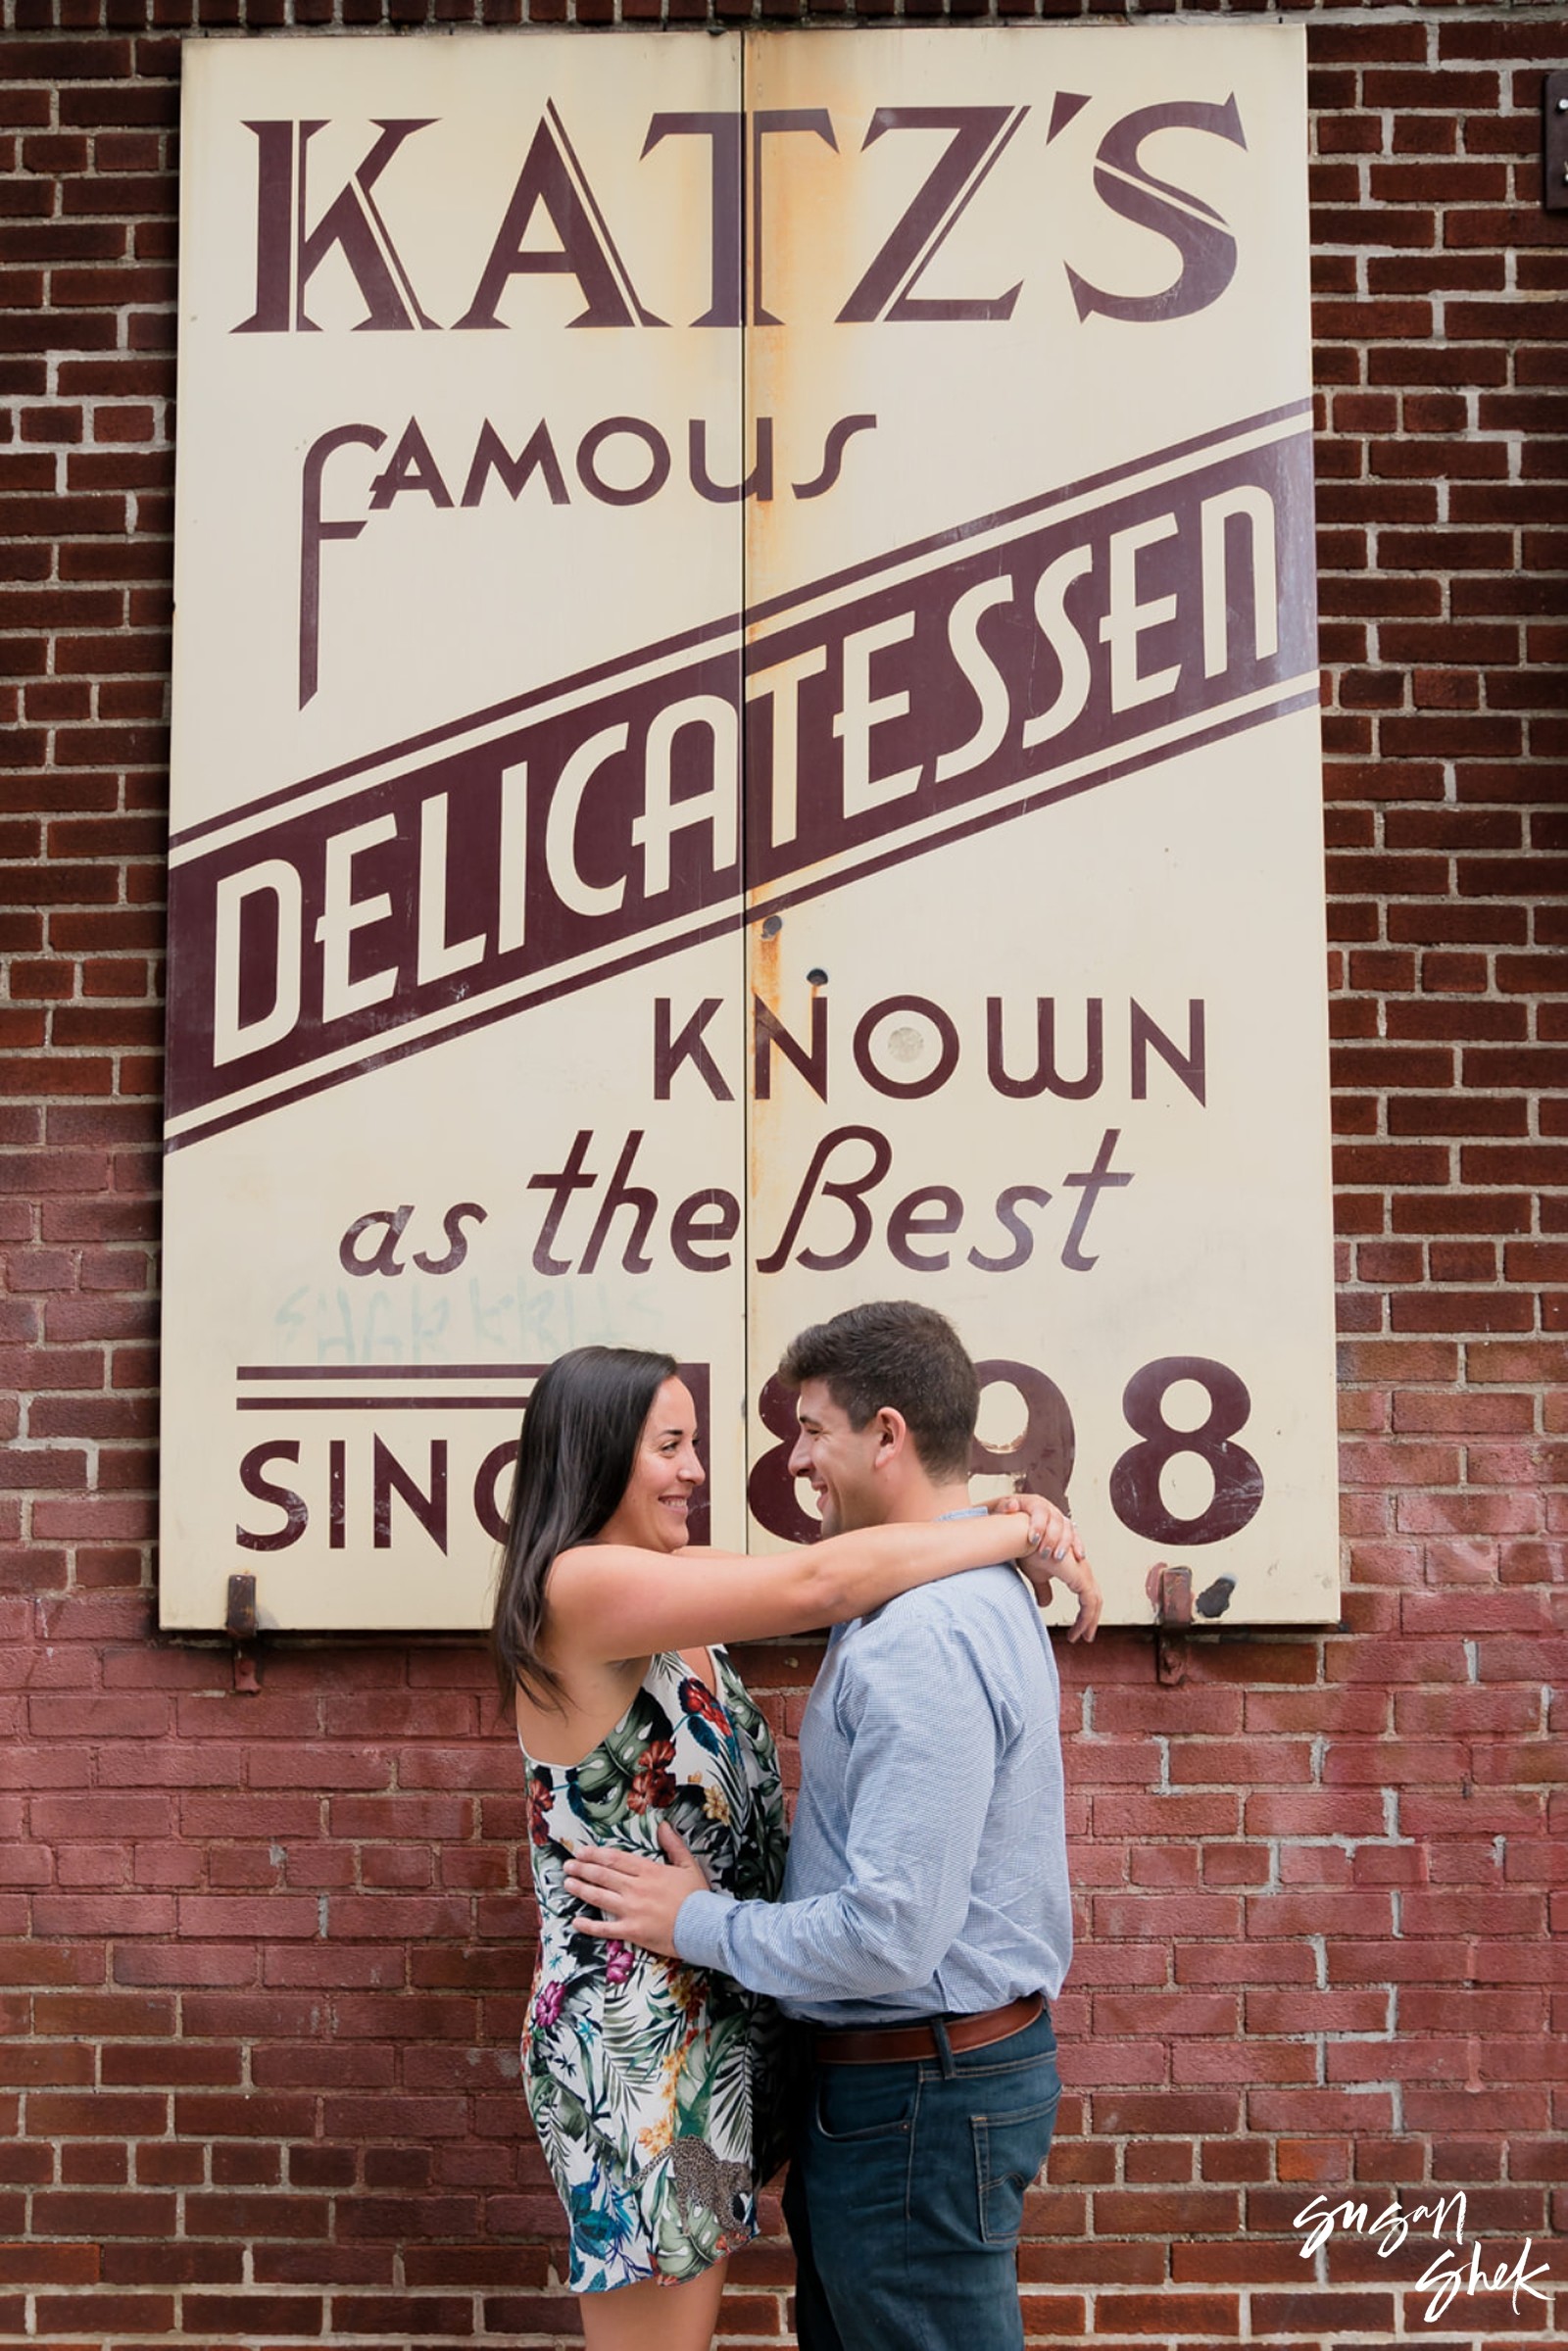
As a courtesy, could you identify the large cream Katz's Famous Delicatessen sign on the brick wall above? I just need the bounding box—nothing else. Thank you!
[163,25,1338,1627]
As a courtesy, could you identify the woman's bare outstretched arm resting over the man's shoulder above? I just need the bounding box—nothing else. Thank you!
[535,1502,1069,1662]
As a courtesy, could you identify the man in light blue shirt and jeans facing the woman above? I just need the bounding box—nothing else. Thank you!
[566,1302,1101,2351]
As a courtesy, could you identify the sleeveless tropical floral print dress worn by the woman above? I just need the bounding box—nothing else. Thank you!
[522,1645,785,2294]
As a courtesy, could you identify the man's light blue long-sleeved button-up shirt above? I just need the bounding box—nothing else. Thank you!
[674,1566,1072,2025]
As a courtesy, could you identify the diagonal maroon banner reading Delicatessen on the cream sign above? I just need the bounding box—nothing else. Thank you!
[170,412,1316,1148]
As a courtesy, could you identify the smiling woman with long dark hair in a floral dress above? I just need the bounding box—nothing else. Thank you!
[491,1347,1062,2351]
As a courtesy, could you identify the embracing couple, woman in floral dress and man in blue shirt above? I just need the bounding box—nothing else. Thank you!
[494,1302,1101,2351]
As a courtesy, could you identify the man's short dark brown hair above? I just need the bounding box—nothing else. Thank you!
[778,1298,980,1479]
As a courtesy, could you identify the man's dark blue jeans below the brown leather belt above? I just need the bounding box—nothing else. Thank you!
[783,2013,1060,2351]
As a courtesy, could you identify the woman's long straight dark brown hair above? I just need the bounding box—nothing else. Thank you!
[489,1347,674,1707]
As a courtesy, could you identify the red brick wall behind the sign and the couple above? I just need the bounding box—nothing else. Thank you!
[0,0,1568,2351]
